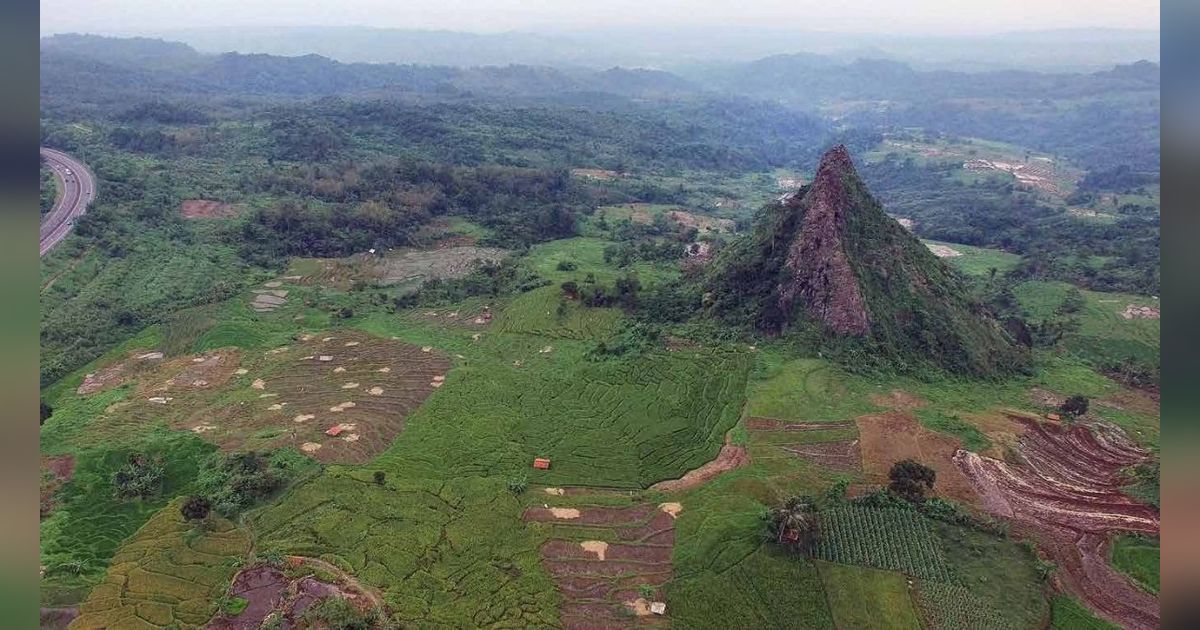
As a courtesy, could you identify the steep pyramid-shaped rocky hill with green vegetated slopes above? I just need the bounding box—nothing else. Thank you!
[709,145,1027,376]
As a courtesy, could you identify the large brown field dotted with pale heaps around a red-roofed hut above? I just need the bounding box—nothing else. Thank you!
[182,330,450,462]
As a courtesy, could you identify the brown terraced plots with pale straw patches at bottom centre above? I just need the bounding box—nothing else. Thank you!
[524,504,683,630]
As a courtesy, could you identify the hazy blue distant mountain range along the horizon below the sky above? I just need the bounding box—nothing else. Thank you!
[41,35,1159,106]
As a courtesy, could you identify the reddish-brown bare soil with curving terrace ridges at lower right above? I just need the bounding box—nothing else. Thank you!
[955,419,1159,630]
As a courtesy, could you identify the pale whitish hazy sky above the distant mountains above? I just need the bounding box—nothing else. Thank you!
[42,0,1159,35]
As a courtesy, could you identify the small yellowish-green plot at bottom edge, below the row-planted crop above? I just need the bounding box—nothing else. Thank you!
[817,562,922,630]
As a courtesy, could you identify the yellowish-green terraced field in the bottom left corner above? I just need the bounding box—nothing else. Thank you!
[71,502,250,630]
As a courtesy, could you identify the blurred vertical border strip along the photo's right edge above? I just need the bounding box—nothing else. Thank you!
[1160,0,1200,628]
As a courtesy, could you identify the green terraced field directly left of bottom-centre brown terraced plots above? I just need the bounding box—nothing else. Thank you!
[250,467,558,628]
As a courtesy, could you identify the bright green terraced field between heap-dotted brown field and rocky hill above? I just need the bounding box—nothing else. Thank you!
[369,343,749,488]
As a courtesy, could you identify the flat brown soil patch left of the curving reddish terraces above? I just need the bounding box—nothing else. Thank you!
[856,412,977,503]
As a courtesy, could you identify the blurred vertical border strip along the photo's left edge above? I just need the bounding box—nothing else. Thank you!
[0,0,38,628]
